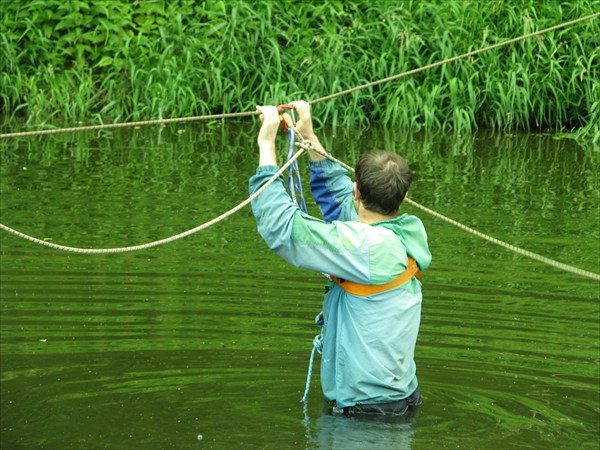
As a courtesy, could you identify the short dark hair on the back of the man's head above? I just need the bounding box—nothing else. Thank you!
[355,150,412,216]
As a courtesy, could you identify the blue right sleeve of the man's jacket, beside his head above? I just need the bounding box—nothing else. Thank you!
[310,159,356,222]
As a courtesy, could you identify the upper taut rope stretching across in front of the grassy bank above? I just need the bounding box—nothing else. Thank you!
[0,13,600,139]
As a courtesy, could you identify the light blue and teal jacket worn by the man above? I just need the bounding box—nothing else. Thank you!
[250,160,431,408]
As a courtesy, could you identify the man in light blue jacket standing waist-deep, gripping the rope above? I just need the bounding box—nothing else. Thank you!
[249,101,431,415]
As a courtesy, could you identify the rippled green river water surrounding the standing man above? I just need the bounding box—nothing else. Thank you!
[0,124,600,450]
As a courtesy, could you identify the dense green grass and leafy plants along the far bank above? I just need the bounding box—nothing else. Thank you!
[0,0,600,142]
